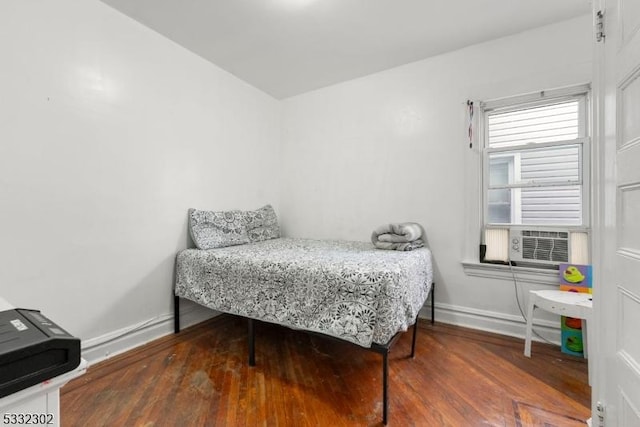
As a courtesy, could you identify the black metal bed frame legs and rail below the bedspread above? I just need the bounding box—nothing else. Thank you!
[173,282,436,425]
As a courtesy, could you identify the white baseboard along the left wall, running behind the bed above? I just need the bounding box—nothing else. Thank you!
[82,302,219,366]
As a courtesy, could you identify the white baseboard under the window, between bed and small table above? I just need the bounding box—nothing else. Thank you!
[420,303,560,345]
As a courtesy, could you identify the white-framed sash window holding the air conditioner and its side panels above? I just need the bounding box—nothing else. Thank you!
[481,86,590,263]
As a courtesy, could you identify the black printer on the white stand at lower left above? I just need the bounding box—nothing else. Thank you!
[0,309,80,398]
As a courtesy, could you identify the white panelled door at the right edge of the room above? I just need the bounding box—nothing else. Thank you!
[593,0,640,427]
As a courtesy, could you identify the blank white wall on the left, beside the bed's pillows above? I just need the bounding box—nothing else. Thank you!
[0,0,281,352]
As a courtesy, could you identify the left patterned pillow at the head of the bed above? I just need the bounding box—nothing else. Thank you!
[189,209,249,249]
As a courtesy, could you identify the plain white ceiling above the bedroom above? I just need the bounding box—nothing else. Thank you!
[102,0,591,99]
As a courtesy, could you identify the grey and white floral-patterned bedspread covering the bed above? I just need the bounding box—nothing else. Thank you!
[175,238,433,347]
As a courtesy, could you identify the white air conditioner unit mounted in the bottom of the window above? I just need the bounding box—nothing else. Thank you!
[509,227,571,265]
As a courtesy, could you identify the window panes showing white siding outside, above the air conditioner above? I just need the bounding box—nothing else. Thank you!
[487,100,584,225]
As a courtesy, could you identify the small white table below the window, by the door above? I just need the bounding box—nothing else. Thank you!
[524,290,593,384]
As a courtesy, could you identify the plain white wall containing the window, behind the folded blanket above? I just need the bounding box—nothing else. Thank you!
[280,16,592,333]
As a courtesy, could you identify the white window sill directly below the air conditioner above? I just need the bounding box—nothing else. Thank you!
[462,261,560,286]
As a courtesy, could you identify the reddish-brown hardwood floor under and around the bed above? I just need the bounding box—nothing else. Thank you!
[61,315,591,427]
